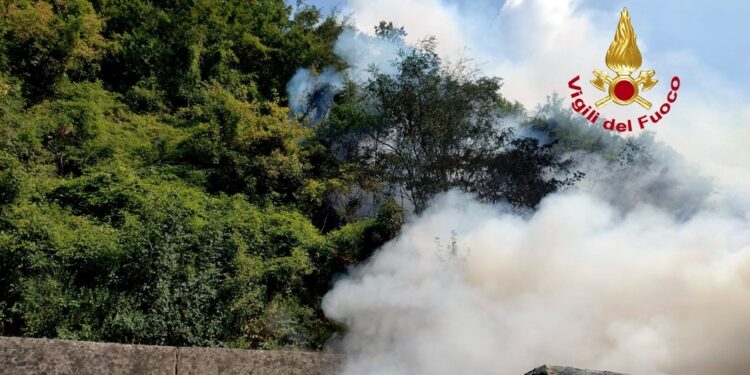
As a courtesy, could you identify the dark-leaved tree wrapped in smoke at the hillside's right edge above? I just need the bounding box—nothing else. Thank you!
[323,39,579,212]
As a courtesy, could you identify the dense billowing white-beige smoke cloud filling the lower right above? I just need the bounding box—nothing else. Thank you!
[324,192,750,375]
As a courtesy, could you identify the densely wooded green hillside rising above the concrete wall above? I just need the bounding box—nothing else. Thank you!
[0,0,580,349]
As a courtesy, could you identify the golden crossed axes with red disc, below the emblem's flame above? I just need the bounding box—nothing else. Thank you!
[591,69,659,109]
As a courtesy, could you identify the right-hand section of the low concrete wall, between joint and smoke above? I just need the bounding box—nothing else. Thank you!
[177,348,343,375]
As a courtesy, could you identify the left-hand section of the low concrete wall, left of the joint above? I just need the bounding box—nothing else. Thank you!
[0,337,177,375]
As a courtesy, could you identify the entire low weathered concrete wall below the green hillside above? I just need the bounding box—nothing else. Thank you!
[0,337,342,375]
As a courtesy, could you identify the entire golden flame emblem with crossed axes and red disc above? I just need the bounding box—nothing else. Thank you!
[591,8,659,109]
